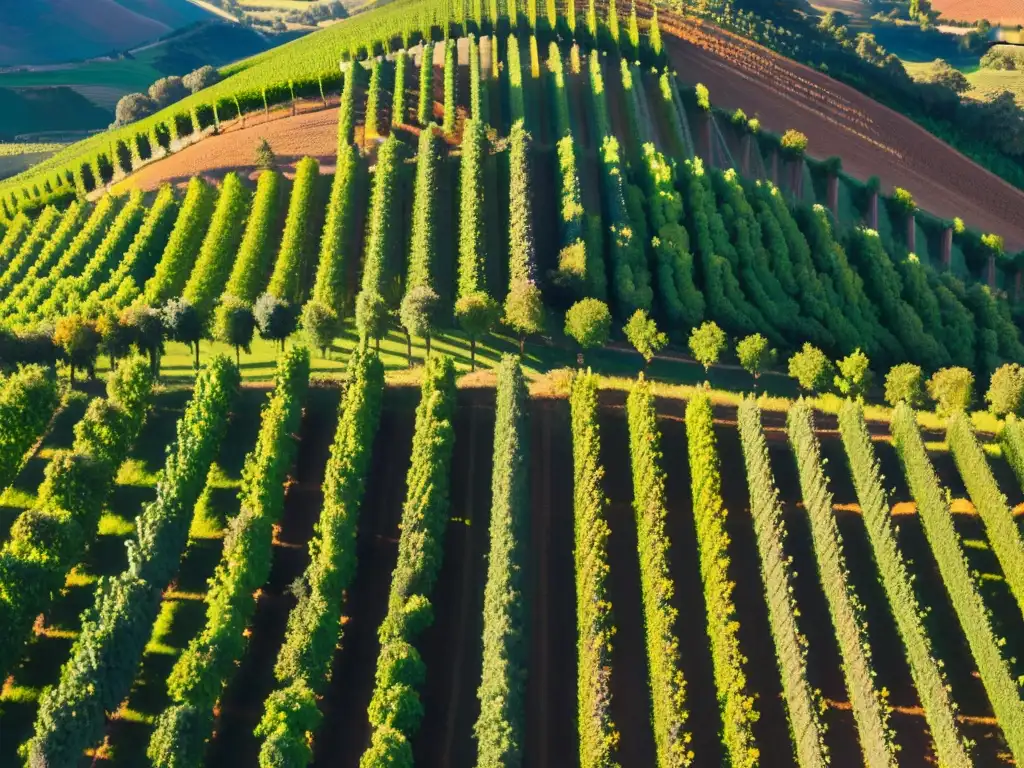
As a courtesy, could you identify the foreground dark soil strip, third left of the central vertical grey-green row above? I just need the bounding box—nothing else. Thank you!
[207,386,341,768]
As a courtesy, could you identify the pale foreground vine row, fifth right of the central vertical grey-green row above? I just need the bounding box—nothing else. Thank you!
[786,399,897,768]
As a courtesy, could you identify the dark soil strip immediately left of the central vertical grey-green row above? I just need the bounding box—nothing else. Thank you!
[413,390,495,768]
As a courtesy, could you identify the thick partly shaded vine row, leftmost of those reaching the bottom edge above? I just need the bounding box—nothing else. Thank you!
[27,355,239,765]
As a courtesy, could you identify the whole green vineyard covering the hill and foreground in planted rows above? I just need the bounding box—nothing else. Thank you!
[0,0,1024,768]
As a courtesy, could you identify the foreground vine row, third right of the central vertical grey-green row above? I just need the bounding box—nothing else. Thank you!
[686,392,760,768]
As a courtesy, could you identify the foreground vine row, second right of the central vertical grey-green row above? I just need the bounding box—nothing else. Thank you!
[626,377,693,768]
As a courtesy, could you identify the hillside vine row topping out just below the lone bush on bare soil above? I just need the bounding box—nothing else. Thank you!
[223,171,282,303]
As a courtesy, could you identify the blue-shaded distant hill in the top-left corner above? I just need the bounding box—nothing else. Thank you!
[0,0,217,67]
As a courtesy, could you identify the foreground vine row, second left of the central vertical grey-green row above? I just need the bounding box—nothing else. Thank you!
[256,345,384,768]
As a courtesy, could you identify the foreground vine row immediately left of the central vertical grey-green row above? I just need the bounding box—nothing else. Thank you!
[359,356,455,768]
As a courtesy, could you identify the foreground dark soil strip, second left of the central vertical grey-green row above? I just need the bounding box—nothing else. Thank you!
[313,388,416,768]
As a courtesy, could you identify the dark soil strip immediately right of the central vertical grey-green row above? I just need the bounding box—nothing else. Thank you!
[524,399,580,768]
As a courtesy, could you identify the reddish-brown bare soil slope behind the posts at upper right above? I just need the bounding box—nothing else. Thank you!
[660,14,1024,250]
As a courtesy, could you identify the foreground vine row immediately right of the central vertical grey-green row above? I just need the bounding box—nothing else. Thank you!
[569,372,618,768]
